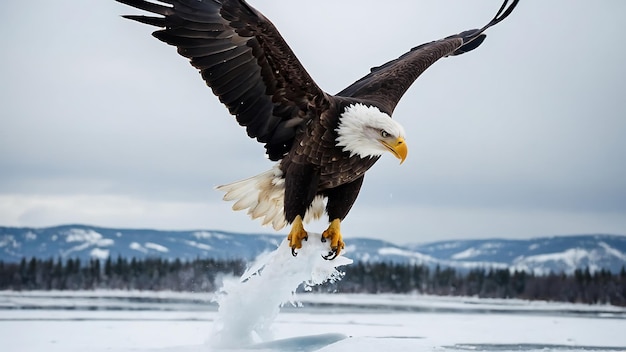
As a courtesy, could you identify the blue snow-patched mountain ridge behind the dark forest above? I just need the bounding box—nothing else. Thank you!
[0,225,626,273]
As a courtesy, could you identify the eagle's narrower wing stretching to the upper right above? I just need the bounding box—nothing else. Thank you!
[337,0,519,115]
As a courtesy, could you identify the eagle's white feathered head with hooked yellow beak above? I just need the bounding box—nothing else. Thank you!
[335,104,408,163]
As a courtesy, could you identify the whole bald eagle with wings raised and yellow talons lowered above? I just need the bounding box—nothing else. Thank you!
[117,0,519,259]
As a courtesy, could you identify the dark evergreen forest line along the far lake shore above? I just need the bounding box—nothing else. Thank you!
[0,257,626,306]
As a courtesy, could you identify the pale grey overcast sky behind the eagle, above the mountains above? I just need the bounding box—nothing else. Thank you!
[0,0,626,243]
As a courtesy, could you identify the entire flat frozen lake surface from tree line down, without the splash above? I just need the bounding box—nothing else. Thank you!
[0,291,626,352]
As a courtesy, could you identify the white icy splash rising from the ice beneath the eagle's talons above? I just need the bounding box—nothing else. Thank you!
[208,233,352,348]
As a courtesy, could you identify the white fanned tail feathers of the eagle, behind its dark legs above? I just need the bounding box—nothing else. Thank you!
[216,164,325,231]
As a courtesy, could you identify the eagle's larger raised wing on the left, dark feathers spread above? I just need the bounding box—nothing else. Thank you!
[117,0,327,160]
